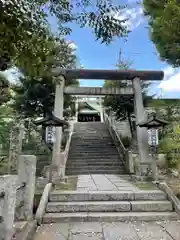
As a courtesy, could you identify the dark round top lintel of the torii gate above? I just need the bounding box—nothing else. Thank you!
[53,68,164,81]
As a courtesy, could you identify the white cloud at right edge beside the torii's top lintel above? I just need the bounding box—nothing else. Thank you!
[158,66,180,93]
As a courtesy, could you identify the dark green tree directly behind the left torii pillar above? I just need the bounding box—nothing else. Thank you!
[14,37,79,117]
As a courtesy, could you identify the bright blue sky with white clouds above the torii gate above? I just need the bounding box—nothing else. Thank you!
[3,0,180,98]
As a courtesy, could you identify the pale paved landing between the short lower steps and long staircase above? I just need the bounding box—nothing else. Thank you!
[77,174,139,192]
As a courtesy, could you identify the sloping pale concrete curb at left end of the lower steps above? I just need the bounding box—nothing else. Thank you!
[35,183,52,225]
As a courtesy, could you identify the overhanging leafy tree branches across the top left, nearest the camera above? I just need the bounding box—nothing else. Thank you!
[0,0,128,72]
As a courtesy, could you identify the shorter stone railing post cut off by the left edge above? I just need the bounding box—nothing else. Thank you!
[0,175,17,240]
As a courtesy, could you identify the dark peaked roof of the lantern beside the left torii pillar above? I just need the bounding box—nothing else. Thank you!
[34,114,69,127]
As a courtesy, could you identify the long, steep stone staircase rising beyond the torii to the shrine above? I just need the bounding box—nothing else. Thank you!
[66,122,125,175]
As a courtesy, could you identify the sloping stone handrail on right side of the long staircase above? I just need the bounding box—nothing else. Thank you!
[103,112,130,171]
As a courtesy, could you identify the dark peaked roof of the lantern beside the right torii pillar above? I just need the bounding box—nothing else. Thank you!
[138,114,168,129]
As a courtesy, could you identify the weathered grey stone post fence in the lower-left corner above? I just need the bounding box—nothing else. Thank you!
[0,155,36,240]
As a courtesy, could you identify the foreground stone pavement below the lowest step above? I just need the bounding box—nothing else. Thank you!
[34,221,180,240]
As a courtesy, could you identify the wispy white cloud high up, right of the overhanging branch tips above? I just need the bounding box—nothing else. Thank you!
[115,7,144,31]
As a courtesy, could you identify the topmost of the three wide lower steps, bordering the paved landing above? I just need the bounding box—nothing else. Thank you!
[49,190,167,202]
